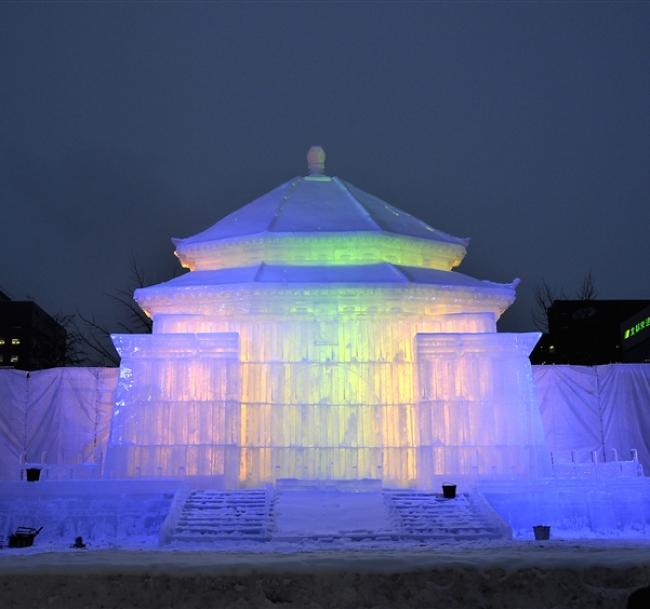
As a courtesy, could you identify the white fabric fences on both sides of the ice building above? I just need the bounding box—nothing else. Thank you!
[0,364,650,479]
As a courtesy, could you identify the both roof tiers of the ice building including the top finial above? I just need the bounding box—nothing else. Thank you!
[135,147,518,317]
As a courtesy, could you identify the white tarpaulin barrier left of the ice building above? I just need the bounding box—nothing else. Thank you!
[0,368,118,479]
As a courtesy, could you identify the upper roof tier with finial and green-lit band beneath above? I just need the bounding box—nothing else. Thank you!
[173,147,468,270]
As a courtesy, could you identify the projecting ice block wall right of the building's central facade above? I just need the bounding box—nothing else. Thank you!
[415,333,549,477]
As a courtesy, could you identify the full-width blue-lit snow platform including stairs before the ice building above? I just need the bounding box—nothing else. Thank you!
[0,477,650,552]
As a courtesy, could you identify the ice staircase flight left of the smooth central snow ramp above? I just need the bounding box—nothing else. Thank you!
[161,488,273,544]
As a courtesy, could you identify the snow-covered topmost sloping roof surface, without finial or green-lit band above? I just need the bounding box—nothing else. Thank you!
[173,175,468,251]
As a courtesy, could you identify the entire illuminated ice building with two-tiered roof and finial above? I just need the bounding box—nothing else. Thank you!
[105,147,547,488]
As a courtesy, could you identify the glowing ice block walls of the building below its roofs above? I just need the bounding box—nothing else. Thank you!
[107,288,546,487]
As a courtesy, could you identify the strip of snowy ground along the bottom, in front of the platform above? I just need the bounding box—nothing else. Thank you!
[0,541,650,609]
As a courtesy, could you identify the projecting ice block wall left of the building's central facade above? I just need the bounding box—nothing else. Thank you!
[105,334,241,483]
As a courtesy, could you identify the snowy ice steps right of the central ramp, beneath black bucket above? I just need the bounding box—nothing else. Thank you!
[384,490,512,542]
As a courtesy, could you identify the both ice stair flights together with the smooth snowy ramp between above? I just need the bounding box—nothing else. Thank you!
[168,486,511,546]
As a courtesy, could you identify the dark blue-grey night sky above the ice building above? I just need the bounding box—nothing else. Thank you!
[0,2,650,331]
